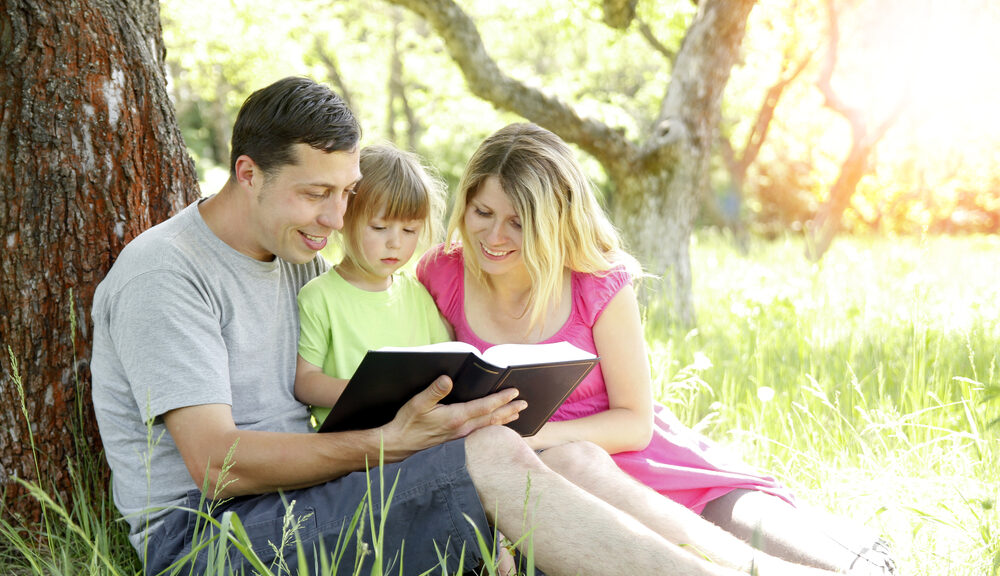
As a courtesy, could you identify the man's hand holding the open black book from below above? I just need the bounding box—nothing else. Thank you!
[382,376,528,457]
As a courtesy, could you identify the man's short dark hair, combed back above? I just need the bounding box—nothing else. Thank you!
[229,76,361,175]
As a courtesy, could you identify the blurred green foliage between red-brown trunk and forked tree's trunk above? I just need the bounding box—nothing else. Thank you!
[161,0,694,192]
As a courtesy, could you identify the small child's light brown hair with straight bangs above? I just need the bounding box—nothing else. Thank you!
[341,143,445,272]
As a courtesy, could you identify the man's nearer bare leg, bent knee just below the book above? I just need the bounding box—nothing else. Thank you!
[465,427,745,576]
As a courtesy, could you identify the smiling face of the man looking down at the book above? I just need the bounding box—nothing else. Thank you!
[250,144,361,264]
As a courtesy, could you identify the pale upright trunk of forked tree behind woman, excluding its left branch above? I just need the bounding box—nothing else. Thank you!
[612,0,755,326]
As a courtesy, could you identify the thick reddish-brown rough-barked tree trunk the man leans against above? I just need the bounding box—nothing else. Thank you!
[0,0,197,520]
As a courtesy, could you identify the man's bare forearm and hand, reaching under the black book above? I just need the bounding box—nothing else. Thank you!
[163,376,526,498]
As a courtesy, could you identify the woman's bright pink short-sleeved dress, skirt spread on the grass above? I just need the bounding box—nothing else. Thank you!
[417,246,794,512]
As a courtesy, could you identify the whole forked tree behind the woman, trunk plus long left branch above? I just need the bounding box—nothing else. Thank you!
[390,0,755,325]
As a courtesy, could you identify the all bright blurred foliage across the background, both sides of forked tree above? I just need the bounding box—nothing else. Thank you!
[161,0,1000,235]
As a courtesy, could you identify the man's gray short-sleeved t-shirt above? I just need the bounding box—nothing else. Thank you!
[91,203,327,549]
